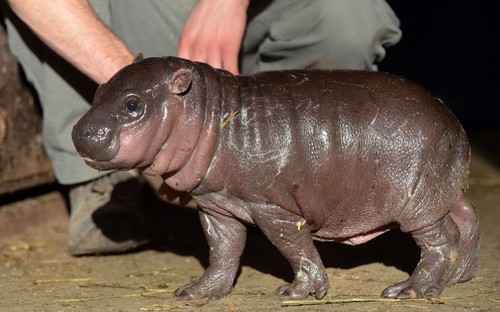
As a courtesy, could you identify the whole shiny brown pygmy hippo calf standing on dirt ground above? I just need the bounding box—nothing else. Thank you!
[72,57,479,299]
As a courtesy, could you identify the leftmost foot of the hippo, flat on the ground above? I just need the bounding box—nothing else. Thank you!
[175,279,233,300]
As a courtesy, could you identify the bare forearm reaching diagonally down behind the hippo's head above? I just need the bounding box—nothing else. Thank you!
[8,0,133,84]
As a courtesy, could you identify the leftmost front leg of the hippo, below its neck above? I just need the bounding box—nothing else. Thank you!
[175,210,246,300]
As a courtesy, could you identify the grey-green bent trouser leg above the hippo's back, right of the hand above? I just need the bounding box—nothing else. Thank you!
[243,0,401,72]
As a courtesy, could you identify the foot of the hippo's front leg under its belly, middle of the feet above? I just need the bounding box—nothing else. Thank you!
[276,263,328,299]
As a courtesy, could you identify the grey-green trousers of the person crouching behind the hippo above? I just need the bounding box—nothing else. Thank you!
[2,0,401,184]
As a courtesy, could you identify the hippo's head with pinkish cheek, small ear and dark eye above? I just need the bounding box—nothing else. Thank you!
[72,56,201,174]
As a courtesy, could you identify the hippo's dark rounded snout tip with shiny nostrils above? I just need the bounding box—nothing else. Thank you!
[71,119,118,170]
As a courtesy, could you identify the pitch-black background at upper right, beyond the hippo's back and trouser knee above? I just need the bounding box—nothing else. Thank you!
[379,0,500,125]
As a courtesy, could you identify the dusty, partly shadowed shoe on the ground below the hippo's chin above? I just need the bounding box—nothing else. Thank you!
[68,171,148,256]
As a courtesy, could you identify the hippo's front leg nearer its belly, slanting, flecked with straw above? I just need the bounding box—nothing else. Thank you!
[253,205,329,299]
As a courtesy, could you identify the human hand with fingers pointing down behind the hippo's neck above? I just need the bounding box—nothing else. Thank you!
[177,0,249,74]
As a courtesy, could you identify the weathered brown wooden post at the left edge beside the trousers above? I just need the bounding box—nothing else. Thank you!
[0,25,54,195]
